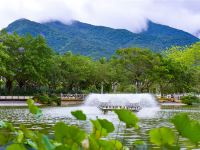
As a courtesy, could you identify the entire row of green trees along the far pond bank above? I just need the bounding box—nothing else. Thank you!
[0,31,200,95]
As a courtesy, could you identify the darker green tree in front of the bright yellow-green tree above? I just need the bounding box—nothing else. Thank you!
[154,57,193,96]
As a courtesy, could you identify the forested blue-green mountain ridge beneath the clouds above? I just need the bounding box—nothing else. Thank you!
[6,19,199,57]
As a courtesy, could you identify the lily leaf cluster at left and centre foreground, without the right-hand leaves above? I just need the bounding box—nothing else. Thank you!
[0,99,138,150]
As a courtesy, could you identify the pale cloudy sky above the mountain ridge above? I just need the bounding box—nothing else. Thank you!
[0,0,200,34]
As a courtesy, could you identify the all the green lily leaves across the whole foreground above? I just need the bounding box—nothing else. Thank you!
[0,99,200,150]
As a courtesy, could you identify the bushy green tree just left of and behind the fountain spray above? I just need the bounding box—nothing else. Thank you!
[61,53,94,93]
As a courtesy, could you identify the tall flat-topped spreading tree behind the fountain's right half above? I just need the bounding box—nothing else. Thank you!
[117,48,160,92]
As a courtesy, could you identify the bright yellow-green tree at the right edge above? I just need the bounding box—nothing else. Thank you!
[164,42,200,92]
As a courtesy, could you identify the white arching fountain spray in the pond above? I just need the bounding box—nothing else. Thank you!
[84,93,159,117]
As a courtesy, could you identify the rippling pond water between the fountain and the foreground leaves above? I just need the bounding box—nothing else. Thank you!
[0,105,200,149]
